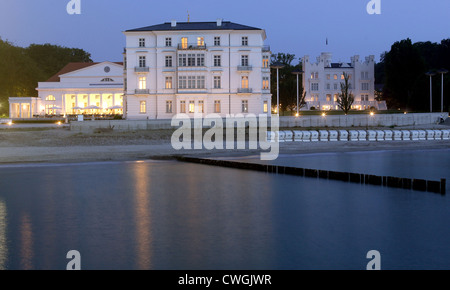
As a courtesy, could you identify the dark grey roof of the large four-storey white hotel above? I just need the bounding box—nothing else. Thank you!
[126,21,262,32]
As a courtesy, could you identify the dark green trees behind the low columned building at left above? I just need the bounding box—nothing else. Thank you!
[0,38,92,115]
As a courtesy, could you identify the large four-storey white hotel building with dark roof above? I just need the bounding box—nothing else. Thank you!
[124,19,271,119]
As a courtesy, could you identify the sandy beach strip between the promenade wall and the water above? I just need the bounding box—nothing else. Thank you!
[0,125,450,164]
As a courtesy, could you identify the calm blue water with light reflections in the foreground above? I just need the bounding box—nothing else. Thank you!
[0,150,450,269]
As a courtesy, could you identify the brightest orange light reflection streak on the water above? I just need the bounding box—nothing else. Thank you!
[133,164,152,269]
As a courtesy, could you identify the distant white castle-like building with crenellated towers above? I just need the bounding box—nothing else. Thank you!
[303,53,387,110]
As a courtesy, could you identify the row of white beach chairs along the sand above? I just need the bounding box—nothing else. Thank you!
[267,130,450,142]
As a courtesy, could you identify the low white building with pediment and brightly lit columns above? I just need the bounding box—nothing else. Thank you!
[9,62,123,119]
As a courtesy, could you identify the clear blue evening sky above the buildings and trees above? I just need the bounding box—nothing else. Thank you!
[0,0,450,61]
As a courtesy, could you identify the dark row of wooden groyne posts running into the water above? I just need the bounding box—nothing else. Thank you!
[176,156,446,195]
